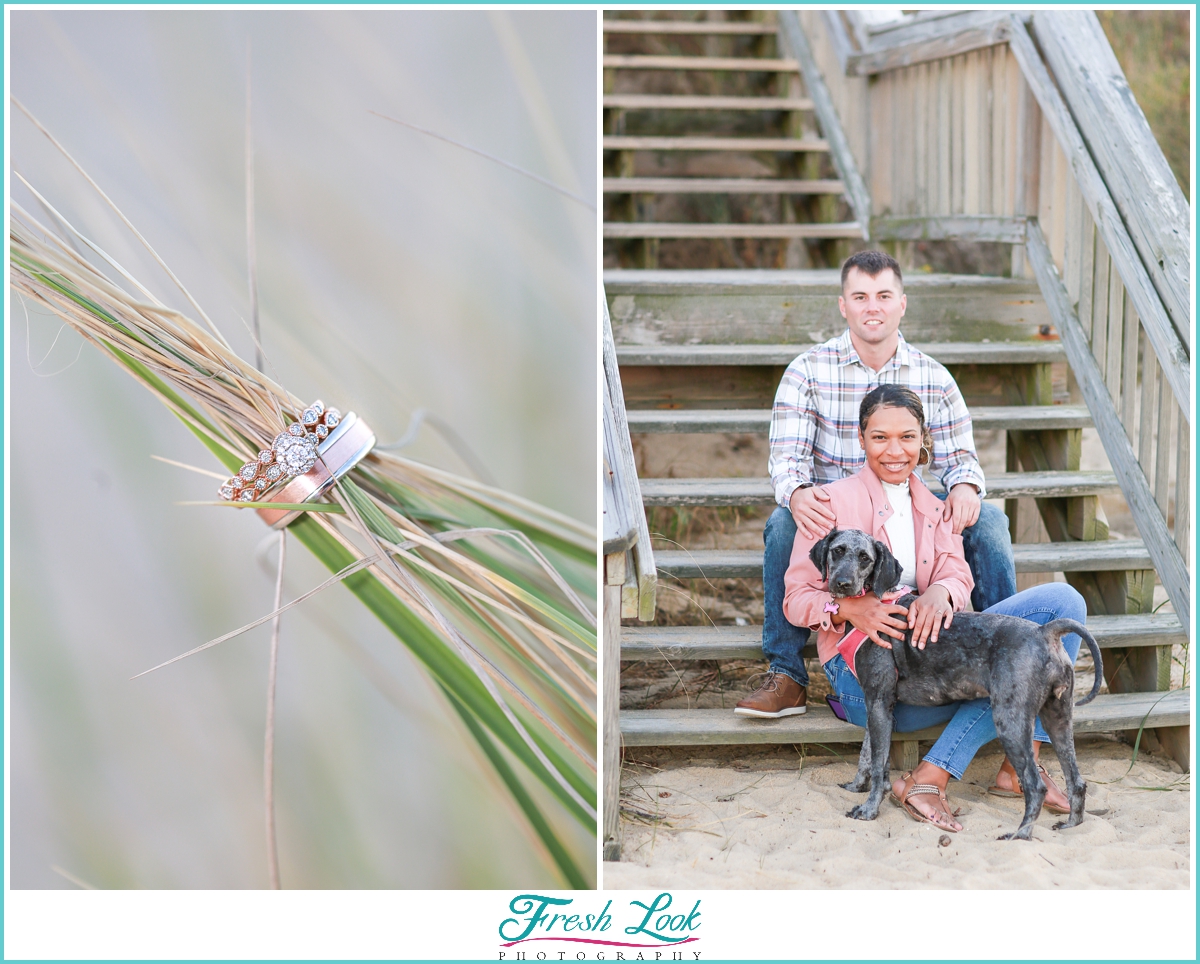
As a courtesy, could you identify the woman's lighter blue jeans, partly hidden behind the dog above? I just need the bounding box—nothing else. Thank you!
[824,582,1087,780]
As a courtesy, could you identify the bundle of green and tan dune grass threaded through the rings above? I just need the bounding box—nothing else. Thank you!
[10,104,596,887]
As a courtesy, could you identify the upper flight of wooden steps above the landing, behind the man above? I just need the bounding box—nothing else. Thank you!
[604,14,865,268]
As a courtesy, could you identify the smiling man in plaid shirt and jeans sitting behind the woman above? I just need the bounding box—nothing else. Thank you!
[733,251,1016,718]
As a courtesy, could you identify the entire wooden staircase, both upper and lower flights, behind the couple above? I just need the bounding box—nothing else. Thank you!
[604,12,1190,825]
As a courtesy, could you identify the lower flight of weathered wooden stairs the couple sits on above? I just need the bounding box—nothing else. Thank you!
[604,270,1188,762]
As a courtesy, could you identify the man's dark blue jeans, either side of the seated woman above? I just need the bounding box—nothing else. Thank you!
[762,496,1016,687]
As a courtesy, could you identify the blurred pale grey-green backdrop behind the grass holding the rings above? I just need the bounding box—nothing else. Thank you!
[8,11,598,888]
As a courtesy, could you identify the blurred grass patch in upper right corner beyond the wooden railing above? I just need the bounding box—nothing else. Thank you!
[1096,10,1192,202]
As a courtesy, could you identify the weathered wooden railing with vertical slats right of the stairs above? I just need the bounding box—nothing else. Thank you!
[779,11,1192,635]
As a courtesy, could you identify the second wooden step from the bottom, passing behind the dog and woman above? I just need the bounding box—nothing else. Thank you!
[620,612,1188,661]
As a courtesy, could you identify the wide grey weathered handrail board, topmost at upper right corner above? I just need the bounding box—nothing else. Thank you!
[1033,10,1192,355]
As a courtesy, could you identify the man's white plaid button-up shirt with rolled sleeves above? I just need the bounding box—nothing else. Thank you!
[768,329,984,507]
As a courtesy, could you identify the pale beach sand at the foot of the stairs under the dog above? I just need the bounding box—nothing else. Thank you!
[602,737,1192,890]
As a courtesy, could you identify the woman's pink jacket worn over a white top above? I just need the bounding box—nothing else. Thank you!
[784,466,974,664]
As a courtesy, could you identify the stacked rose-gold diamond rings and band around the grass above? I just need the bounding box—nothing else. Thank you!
[218,401,376,528]
